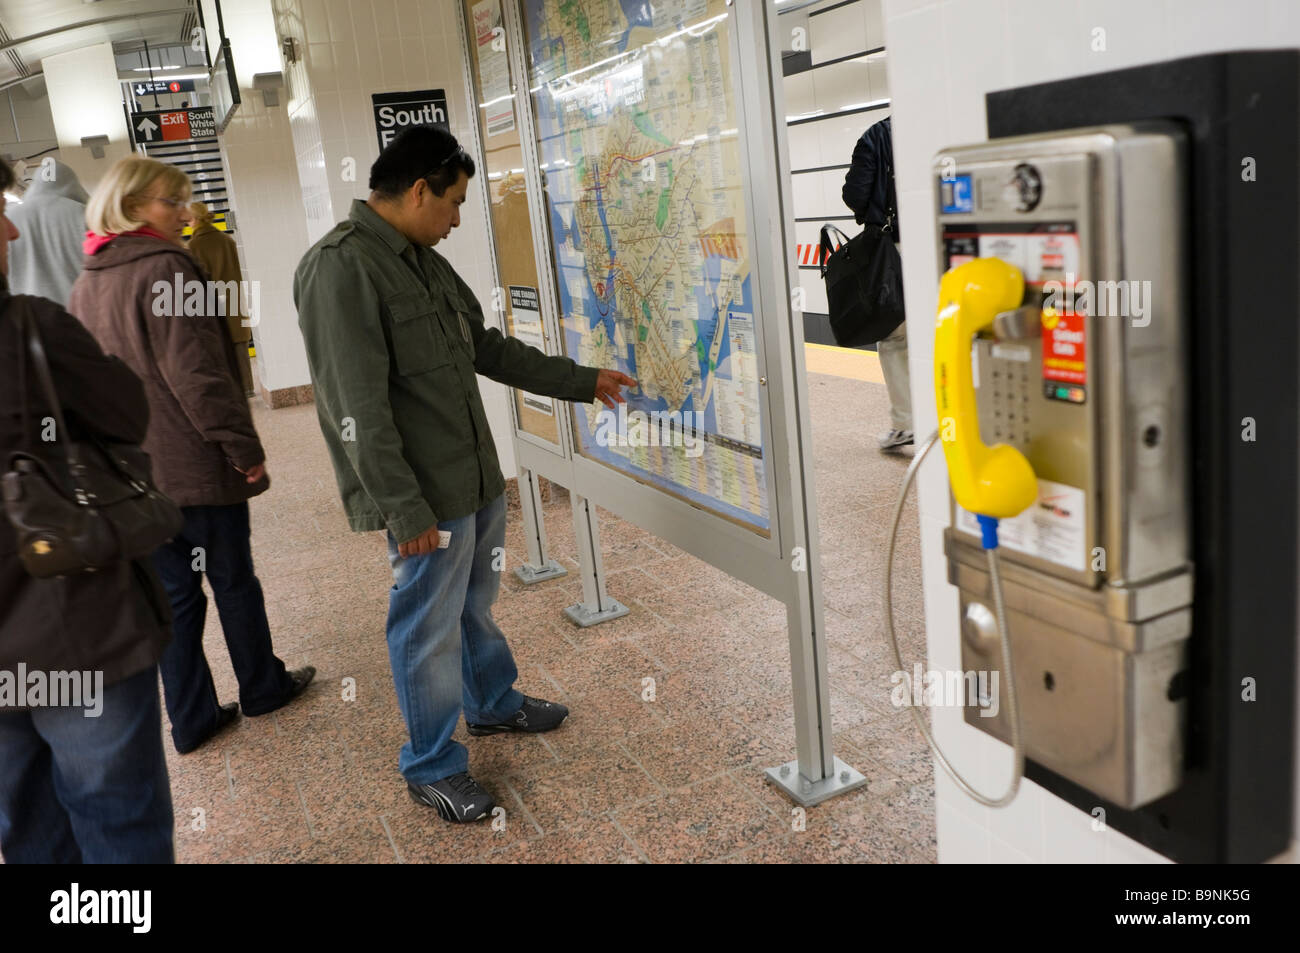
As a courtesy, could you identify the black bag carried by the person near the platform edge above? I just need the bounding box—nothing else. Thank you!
[818,222,904,347]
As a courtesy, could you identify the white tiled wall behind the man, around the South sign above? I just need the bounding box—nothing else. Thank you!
[256,0,515,477]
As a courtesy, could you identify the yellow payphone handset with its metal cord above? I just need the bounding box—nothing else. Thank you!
[884,257,1040,807]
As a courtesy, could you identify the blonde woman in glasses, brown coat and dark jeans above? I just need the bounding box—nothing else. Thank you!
[69,156,316,754]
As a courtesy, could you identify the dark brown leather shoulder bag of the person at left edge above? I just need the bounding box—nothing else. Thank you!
[3,296,185,579]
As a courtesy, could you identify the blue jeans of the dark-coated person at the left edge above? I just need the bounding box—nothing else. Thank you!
[0,666,174,863]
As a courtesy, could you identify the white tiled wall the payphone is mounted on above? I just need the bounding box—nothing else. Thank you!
[884,0,1300,863]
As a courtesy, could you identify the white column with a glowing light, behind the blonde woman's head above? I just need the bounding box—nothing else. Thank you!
[40,43,131,191]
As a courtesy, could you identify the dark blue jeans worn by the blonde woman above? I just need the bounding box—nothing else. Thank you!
[153,503,293,749]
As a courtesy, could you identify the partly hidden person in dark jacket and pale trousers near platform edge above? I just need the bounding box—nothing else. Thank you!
[841,117,913,451]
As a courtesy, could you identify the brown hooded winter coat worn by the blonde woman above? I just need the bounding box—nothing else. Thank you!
[68,235,269,506]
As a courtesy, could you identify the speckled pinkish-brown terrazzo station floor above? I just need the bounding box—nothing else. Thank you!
[166,364,936,863]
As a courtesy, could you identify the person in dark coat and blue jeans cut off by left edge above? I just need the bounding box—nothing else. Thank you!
[0,161,174,863]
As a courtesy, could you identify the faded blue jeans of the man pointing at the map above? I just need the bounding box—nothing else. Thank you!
[389,495,524,784]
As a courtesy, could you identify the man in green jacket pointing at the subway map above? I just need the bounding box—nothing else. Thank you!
[294,126,636,822]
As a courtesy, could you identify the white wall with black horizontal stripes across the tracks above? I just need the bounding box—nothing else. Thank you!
[777,0,889,343]
